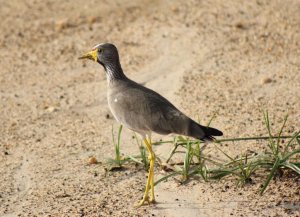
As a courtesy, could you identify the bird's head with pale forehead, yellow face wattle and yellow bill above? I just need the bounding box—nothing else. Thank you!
[79,43,120,70]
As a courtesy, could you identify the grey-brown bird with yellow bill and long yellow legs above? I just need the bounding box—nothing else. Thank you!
[79,43,223,207]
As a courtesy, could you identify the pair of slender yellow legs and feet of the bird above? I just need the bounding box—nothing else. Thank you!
[136,139,155,207]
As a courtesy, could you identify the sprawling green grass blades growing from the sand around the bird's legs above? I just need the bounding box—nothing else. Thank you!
[107,111,300,194]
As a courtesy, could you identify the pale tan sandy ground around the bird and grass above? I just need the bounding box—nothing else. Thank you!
[0,0,300,217]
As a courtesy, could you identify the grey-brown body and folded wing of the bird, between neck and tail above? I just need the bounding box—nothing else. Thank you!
[108,79,191,135]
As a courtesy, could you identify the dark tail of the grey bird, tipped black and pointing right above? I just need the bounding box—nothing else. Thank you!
[189,121,223,141]
